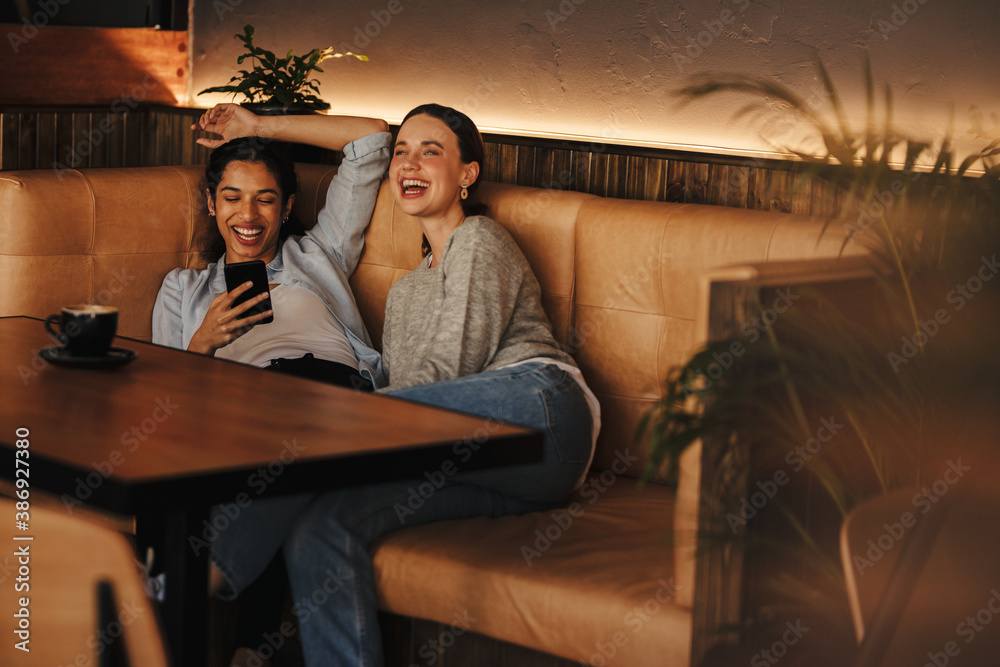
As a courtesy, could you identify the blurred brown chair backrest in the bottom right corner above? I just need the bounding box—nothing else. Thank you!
[840,482,1000,667]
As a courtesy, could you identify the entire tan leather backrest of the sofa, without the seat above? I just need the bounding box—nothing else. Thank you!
[0,164,862,488]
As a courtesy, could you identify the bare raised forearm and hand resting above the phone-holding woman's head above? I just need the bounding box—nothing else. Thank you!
[191,104,389,151]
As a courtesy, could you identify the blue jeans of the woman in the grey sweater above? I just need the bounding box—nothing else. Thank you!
[284,363,592,667]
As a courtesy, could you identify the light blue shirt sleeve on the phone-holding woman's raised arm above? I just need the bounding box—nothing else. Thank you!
[306,132,392,275]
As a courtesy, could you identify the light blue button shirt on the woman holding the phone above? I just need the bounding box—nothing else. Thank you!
[153,132,391,387]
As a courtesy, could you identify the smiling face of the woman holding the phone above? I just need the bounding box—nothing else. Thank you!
[208,161,295,264]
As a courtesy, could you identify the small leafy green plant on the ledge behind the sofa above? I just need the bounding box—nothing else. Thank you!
[198,24,368,115]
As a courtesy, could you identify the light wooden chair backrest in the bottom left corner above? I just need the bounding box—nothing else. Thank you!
[0,498,169,667]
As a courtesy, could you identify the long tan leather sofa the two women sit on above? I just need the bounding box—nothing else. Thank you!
[0,165,860,667]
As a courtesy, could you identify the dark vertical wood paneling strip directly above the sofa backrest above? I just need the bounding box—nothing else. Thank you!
[0,106,816,214]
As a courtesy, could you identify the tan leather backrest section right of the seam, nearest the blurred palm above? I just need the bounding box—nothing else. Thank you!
[573,199,862,482]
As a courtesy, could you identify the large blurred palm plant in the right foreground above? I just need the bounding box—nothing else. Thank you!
[637,63,1000,665]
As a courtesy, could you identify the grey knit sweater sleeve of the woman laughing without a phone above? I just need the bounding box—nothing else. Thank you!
[389,225,523,387]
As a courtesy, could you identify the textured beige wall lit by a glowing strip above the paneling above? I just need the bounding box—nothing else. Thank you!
[191,0,1000,163]
